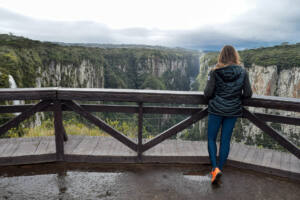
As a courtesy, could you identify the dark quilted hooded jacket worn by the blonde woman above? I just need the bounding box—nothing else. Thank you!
[204,65,252,117]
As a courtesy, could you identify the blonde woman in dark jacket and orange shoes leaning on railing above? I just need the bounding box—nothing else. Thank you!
[204,45,252,183]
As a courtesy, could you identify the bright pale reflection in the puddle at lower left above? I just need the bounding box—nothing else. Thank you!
[0,172,120,199]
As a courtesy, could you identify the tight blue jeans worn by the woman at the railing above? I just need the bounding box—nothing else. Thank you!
[207,114,237,170]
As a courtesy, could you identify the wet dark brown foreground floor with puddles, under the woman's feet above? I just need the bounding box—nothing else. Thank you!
[0,163,300,200]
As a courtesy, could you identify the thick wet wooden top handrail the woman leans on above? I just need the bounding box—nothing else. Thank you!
[0,88,300,112]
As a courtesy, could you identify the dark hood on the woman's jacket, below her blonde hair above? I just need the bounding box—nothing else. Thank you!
[216,65,242,82]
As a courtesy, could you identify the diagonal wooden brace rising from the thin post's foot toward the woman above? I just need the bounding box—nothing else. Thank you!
[142,108,208,152]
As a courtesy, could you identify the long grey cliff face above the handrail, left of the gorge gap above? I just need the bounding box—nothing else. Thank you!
[34,54,199,90]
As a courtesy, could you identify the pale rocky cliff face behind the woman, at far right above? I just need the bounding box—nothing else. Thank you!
[197,56,300,146]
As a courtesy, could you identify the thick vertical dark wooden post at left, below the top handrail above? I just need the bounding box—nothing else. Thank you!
[54,100,64,161]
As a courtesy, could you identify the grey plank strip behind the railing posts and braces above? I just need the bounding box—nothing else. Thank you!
[0,135,300,180]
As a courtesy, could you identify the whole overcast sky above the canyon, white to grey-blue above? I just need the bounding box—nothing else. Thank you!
[0,0,300,50]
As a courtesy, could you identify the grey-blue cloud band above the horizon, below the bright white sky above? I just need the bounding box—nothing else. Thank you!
[0,0,300,50]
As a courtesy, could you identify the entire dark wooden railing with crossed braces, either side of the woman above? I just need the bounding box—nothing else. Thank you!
[0,88,300,160]
